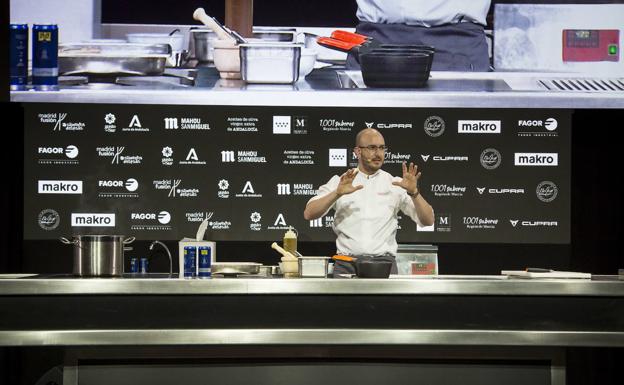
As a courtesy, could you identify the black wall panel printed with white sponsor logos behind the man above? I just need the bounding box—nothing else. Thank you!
[24,103,571,243]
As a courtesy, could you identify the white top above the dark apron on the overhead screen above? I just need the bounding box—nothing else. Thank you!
[357,0,491,27]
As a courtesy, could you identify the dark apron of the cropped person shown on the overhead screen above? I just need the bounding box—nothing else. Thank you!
[347,21,490,72]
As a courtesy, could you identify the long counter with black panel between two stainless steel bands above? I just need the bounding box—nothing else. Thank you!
[0,276,624,347]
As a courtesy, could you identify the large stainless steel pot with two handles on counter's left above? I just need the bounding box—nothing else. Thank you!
[61,235,135,277]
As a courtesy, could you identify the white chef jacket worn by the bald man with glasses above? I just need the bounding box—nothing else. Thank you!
[309,170,421,256]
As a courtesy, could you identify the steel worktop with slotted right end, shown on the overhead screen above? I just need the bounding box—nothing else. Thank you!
[11,67,624,109]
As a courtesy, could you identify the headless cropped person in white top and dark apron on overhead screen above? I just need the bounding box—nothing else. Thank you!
[347,0,491,71]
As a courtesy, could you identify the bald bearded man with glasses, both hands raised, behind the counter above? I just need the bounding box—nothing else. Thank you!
[303,128,434,277]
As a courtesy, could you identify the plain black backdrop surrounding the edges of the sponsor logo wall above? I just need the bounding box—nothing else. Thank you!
[0,104,624,274]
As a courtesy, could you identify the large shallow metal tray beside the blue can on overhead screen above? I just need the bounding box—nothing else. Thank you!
[58,42,171,75]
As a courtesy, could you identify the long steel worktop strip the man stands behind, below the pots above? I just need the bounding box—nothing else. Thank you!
[0,275,624,297]
